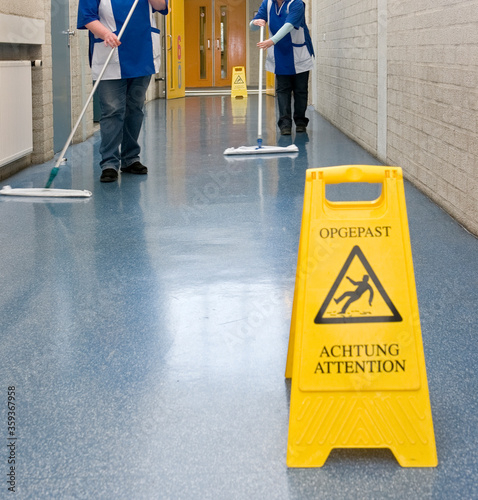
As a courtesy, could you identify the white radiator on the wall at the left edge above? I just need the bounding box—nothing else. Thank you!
[0,61,33,166]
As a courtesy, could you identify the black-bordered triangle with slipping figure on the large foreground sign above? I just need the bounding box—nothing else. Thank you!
[314,246,402,324]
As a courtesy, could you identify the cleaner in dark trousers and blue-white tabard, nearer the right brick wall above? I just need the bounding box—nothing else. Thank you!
[250,0,314,135]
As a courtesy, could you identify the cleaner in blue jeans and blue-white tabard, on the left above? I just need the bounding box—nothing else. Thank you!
[77,0,168,182]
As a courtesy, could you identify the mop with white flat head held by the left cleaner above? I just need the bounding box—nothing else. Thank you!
[0,0,139,198]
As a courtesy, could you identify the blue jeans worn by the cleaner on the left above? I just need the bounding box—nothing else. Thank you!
[97,75,151,170]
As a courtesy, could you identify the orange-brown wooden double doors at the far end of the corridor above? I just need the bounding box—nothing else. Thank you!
[184,0,246,87]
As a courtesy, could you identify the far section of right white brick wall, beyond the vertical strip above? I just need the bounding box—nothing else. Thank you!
[311,0,377,150]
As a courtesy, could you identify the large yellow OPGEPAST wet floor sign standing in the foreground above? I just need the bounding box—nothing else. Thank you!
[286,165,437,467]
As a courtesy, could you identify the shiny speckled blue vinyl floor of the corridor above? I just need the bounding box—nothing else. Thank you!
[0,96,478,500]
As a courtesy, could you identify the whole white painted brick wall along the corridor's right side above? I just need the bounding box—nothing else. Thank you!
[311,0,478,234]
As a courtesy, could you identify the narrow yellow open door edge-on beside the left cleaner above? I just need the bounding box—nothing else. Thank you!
[166,0,186,99]
